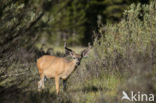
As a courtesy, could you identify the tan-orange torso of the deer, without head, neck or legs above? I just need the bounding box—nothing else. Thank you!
[37,55,74,78]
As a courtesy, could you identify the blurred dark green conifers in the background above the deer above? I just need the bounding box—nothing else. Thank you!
[39,0,141,44]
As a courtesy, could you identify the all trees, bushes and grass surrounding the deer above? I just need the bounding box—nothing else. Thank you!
[0,0,156,103]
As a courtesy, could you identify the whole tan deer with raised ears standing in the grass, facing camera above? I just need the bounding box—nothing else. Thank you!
[37,42,91,94]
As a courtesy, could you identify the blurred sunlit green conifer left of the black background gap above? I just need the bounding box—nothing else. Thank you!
[50,0,86,43]
